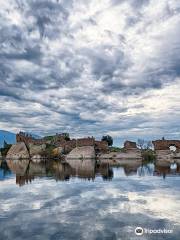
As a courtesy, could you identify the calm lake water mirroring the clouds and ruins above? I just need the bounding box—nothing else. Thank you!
[0,160,180,240]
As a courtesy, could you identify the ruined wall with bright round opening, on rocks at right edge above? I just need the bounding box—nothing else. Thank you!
[152,139,180,164]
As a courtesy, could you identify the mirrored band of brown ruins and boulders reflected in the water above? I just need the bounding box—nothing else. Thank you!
[0,159,180,186]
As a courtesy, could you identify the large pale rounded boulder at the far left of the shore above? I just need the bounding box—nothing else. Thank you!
[6,142,30,159]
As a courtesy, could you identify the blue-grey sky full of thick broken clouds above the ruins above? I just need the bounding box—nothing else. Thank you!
[0,0,180,144]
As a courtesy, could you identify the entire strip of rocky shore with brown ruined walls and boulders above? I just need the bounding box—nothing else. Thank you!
[0,133,180,164]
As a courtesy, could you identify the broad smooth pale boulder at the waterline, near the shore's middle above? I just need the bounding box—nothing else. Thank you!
[66,146,95,160]
